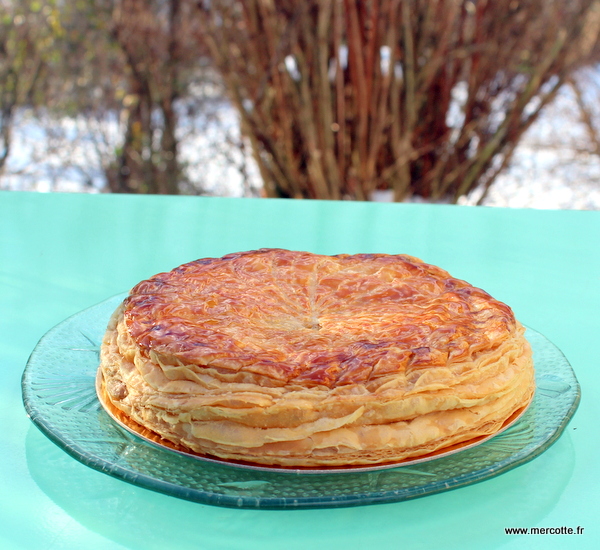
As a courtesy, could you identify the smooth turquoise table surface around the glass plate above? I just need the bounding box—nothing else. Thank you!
[0,192,600,550]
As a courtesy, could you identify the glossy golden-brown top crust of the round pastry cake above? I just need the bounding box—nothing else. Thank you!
[125,249,515,388]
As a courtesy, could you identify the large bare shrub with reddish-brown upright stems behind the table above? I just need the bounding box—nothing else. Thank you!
[198,0,598,201]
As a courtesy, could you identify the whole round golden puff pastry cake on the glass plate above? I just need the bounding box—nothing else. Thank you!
[100,249,535,468]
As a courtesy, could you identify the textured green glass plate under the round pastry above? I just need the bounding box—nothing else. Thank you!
[22,294,580,509]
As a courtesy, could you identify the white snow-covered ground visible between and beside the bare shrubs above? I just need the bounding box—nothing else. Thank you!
[0,90,600,210]
